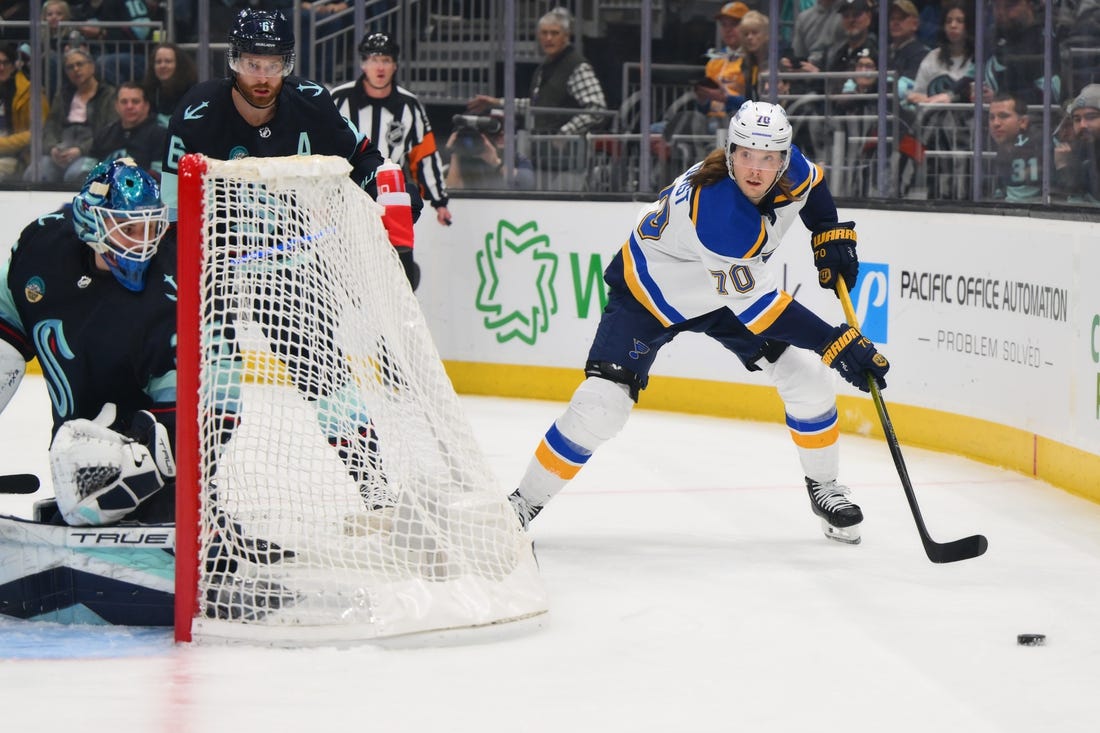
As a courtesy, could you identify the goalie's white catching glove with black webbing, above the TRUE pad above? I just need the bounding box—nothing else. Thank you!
[50,403,176,526]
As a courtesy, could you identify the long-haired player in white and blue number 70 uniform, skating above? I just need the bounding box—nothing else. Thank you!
[509,101,890,544]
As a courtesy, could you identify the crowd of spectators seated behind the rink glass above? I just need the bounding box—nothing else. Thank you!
[0,0,1100,205]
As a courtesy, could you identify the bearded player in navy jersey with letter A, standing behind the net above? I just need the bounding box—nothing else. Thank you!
[162,10,413,504]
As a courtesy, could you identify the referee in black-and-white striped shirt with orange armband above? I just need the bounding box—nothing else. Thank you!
[332,33,451,226]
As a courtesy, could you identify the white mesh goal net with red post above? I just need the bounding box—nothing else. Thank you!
[176,155,546,644]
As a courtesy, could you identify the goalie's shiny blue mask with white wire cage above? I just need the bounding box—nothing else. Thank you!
[73,157,168,293]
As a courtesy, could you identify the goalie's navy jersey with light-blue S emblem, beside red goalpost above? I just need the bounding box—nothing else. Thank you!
[0,207,176,438]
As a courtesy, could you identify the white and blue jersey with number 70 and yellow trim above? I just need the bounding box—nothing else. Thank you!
[623,146,837,348]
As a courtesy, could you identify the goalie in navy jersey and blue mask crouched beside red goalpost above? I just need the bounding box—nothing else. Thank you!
[0,157,176,525]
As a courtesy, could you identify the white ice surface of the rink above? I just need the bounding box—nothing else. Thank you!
[0,378,1100,733]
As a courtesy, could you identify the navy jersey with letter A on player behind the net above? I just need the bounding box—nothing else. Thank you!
[161,76,384,219]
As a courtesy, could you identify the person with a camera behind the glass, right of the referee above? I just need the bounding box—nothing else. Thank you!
[447,110,535,190]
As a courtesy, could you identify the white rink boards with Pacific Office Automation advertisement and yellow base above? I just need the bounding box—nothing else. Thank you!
[0,192,1100,501]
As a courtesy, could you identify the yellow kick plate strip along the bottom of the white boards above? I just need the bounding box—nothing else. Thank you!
[444,361,1100,504]
